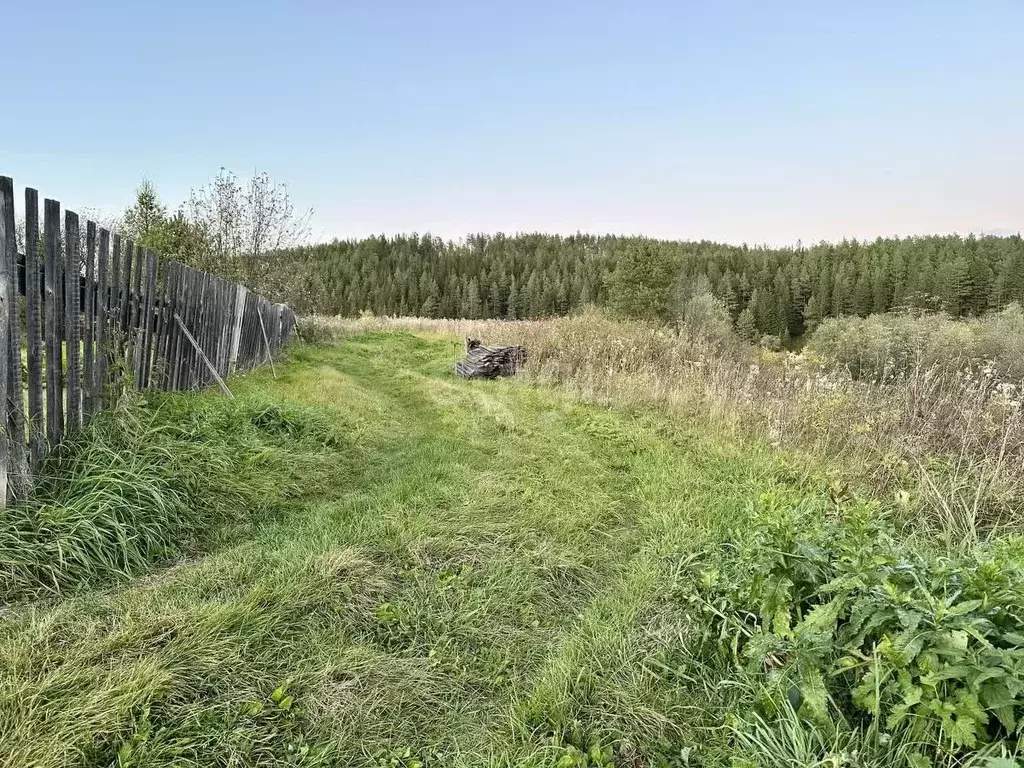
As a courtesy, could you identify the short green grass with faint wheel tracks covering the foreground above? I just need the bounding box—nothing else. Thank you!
[0,334,1015,768]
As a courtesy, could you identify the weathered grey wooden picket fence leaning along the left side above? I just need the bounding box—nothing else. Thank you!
[0,176,295,508]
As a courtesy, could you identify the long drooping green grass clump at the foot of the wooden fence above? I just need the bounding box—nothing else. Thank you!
[0,394,343,601]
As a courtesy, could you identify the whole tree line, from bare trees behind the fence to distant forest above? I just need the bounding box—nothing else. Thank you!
[116,177,1024,342]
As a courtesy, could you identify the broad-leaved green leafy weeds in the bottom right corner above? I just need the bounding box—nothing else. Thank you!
[684,493,1024,767]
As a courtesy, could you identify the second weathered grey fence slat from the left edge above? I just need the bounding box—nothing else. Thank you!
[25,188,46,469]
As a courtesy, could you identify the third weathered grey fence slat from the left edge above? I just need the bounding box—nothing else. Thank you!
[43,200,63,445]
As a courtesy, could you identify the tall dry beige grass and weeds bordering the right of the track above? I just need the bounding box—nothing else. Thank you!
[303,311,1024,546]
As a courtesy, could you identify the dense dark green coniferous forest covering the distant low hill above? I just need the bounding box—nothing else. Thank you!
[271,234,1024,340]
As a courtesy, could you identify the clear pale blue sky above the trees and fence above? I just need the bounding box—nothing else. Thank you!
[0,0,1024,243]
